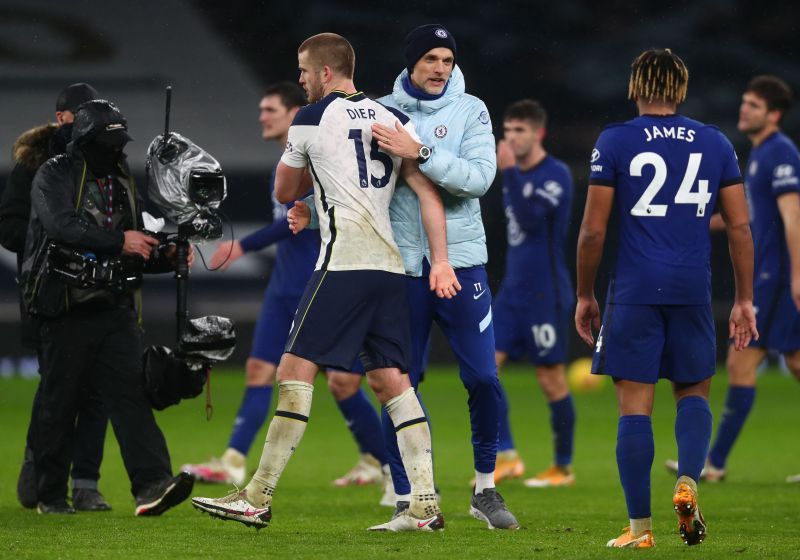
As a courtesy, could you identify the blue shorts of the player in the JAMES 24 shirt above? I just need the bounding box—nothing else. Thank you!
[592,304,716,384]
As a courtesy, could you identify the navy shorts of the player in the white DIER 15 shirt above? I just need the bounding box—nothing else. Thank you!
[286,270,411,372]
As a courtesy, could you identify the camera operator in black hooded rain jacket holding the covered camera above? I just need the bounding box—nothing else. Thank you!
[22,100,194,515]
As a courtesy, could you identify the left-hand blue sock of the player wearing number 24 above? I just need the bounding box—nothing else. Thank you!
[617,414,655,519]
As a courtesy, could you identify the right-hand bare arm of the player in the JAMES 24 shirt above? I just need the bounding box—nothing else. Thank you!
[718,183,758,350]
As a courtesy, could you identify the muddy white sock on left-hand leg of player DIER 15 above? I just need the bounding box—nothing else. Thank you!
[245,381,314,507]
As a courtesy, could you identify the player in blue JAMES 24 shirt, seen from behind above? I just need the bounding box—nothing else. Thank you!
[575,49,758,547]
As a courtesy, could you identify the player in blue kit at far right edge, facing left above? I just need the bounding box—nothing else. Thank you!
[667,76,800,482]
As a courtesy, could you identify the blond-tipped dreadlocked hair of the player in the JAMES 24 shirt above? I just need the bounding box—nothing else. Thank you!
[628,49,689,103]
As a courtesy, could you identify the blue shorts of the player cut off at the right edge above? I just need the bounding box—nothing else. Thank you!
[750,280,800,353]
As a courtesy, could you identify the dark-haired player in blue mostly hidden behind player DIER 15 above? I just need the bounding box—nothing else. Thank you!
[181,82,391,494]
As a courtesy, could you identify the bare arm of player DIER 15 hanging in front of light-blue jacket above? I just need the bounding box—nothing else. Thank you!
[401,159,461,299]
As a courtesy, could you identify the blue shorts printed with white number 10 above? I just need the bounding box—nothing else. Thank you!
[492,288,570,366]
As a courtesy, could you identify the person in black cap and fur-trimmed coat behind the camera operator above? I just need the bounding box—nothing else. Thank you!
[0,83,111,511]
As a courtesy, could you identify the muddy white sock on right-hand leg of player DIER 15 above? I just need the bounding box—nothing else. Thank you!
[386,388,439,519]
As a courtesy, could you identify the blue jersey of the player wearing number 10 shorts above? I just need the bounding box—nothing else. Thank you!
[503,155,575,307]
